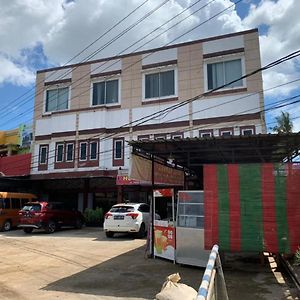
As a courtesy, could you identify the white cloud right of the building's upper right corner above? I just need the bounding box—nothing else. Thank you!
[242,0,300,96]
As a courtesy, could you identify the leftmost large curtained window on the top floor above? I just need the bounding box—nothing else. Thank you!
[45,87,69,112]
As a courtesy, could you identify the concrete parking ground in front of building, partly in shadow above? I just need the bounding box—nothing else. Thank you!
[0,228,299,300]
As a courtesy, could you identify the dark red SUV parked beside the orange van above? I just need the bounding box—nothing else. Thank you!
[18,202,84,233]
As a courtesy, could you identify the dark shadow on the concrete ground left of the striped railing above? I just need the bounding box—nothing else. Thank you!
[43,247,204,299]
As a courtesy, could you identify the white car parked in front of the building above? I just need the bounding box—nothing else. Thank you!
[103,203,157,238]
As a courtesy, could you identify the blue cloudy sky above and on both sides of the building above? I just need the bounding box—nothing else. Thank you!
[0,0,300,132]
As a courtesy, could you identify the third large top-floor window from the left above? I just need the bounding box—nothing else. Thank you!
[144,70,176,99]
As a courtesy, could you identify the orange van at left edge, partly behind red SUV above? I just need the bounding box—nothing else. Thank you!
[0,192,36,231]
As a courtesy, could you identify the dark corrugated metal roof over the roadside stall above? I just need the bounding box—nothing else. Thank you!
[129,133,300,170]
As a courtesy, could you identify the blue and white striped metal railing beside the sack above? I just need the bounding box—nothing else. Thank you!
[197,245,228,300]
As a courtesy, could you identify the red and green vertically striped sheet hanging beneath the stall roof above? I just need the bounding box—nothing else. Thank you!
[204,163,300,253]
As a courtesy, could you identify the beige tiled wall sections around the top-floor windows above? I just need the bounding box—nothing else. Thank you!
[34,31,264,134]
